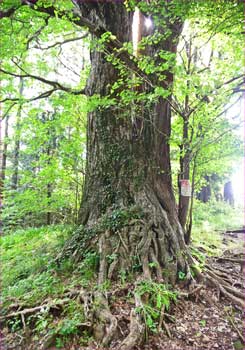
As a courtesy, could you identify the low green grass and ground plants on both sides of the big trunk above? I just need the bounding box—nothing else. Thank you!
[0,201,243,348]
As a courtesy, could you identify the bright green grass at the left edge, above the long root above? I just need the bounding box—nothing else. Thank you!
[0,226,71,305]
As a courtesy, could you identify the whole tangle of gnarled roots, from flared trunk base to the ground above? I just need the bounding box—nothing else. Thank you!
[0,206,245,350]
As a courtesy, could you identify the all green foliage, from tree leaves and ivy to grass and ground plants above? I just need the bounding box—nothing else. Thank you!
[0,0,243,348]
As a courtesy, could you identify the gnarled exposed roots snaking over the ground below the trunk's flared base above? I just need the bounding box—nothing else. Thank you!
[0,268,245,350]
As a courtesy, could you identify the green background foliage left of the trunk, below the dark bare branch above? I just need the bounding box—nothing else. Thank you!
[2,96,85,229]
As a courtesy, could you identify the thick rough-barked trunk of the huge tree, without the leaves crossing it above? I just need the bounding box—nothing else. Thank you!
[72,3,191,283]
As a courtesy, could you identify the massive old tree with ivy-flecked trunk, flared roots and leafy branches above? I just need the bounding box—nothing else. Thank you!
[0,0,243,349]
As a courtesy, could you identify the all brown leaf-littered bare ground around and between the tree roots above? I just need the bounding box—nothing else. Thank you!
[0,233,244,350]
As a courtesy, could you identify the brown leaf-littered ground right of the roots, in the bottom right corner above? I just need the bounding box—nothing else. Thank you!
[137,234,245,350]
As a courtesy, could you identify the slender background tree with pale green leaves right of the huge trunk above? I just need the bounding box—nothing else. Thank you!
[173,16,244,242]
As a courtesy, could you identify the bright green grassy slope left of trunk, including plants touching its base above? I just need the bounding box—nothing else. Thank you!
[0,225,98,309]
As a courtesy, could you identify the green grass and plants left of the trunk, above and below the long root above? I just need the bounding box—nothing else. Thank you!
[0,225,97,348]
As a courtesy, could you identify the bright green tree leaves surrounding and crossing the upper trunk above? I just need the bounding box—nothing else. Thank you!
[0,0,243,234]
